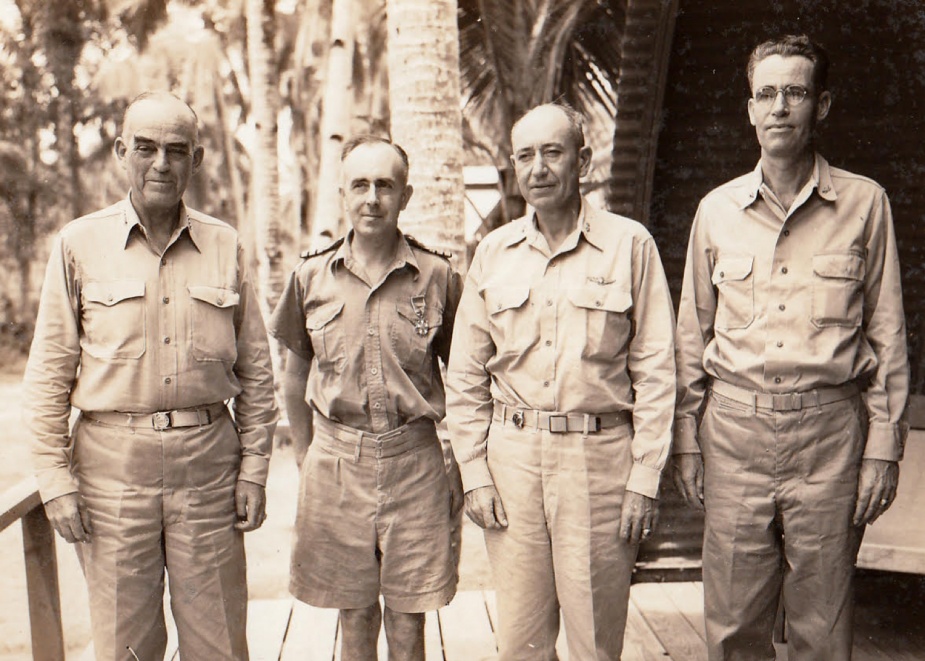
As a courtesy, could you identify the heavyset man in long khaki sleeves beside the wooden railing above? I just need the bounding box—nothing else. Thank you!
[25,93,277,661]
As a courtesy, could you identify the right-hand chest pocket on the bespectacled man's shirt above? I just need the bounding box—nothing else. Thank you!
[812,252,866,328]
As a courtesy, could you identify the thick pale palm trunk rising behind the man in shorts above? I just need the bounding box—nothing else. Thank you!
[387,0,465,268]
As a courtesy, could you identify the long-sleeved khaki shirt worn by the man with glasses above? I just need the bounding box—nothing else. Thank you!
[674,155,909,460]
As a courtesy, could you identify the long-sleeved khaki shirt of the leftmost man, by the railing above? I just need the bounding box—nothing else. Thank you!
[24,200,277,502]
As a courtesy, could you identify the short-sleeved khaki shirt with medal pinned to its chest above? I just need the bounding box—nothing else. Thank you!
[269,232,461,434]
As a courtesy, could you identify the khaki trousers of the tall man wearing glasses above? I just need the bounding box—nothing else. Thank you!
[700,393,866,661]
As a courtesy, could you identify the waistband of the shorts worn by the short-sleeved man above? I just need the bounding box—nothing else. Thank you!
[312,411,437,462]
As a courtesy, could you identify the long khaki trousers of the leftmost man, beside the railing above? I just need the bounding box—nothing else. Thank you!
[74,413,248,661]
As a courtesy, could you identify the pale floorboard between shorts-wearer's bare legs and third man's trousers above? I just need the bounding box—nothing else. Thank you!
[438,590,498,661]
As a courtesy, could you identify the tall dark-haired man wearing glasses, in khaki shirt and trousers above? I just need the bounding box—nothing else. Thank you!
[673,36,908,661]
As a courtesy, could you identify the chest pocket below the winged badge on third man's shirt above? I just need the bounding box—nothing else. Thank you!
[566,285,633,360]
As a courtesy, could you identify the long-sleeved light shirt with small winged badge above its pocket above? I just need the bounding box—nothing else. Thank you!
[447,200,675,497]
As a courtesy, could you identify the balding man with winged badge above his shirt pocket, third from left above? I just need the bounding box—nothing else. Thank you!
[447,104,675,661]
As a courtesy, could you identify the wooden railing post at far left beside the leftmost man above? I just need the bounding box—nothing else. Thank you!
[22,505,64,661]
